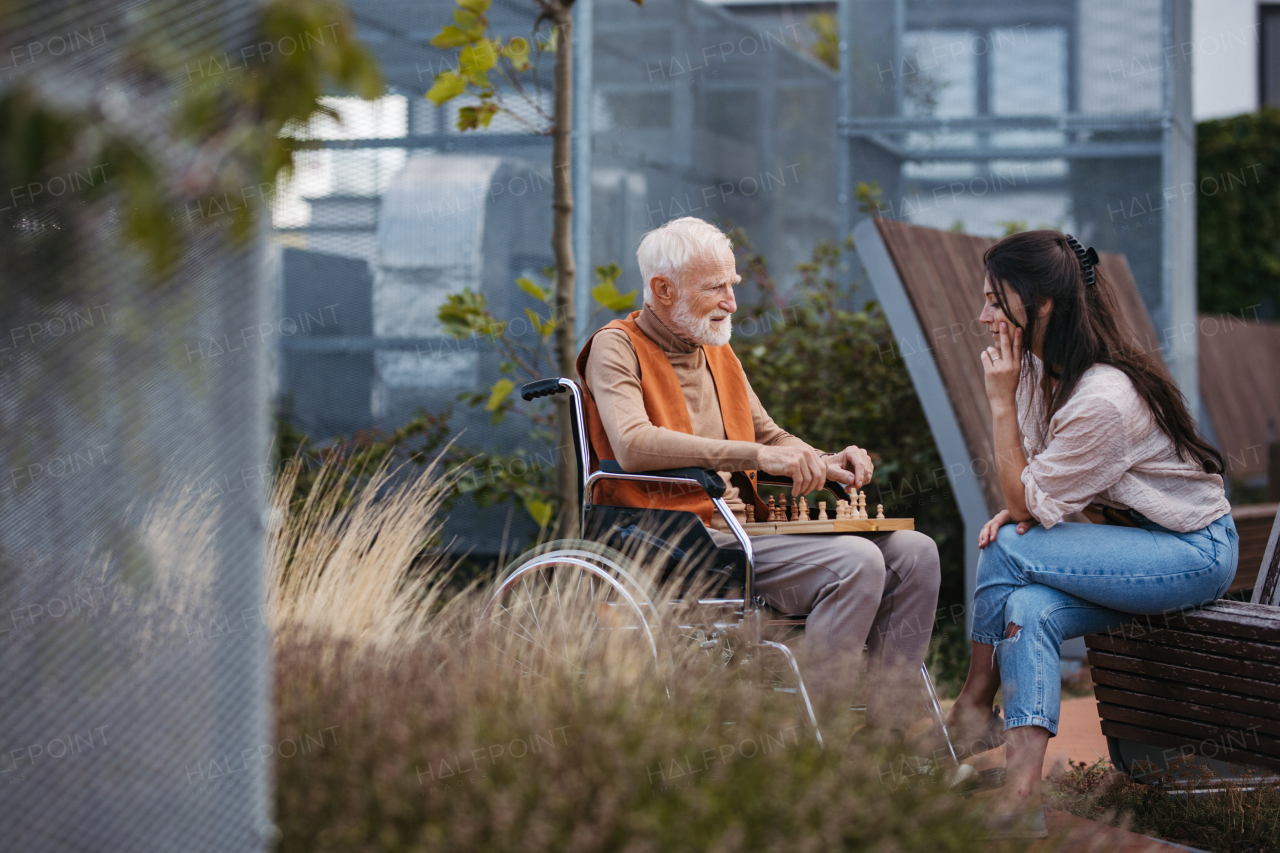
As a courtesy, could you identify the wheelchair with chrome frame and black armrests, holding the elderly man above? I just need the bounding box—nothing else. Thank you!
[481,378,964,776]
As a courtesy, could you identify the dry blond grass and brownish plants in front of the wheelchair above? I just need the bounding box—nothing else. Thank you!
[262,458,1029,853]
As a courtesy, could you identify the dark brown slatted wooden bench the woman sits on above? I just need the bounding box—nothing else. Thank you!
[1084,504,1280,781]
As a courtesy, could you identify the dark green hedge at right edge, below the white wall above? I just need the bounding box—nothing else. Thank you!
[1192,106,1280,319]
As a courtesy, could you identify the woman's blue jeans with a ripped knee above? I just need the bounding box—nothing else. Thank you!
[973,512,1239,735]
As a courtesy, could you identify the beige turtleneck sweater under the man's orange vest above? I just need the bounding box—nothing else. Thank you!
[585,305,806,471]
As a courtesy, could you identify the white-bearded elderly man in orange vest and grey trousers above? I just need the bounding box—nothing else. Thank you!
[577,216,940,727]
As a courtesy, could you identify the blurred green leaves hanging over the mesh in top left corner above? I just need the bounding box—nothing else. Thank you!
[0,0,384,286]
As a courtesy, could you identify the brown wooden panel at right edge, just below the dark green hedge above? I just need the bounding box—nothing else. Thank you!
[1199,314,1280,480]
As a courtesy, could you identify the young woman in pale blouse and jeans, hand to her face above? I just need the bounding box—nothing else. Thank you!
[947,231,1238,835]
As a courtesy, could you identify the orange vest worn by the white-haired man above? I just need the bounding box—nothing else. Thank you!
[577,311,765,523]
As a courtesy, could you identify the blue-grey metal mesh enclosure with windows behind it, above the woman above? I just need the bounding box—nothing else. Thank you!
[840,0,1198,402]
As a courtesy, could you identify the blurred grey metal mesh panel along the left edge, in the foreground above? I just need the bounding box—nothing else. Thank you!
[0,0,272,852]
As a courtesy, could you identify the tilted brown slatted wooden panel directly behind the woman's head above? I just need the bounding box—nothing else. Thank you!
[876,219,1164,514]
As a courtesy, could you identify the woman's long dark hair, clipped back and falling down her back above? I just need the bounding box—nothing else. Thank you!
[982,231,1226,474]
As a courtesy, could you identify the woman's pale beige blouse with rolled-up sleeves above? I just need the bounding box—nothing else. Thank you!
[1018,356,1231,533]
